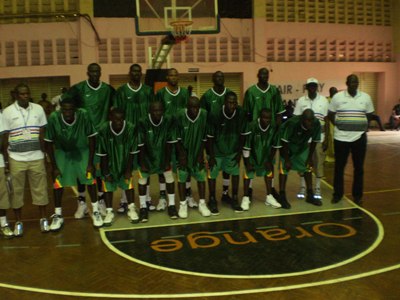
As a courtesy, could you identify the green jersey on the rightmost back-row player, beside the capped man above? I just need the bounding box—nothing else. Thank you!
[243,84,285,124]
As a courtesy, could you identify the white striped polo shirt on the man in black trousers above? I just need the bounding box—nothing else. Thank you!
[329,90,374,142]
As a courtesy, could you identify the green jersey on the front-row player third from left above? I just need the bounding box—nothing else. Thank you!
[139,114,177,174]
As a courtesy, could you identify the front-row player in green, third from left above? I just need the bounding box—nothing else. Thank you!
[139,101,178,222]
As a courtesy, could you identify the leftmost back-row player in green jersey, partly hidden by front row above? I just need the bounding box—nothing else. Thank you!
[62,63,115,219]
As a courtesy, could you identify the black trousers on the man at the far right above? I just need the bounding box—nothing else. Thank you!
[333,133,367,200]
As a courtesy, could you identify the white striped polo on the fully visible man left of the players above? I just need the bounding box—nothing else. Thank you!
[3,101,47,161]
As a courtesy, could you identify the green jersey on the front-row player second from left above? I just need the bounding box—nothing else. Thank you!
[96,121,140,180]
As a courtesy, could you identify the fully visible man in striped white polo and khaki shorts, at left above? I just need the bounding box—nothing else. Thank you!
[3,84,50,236]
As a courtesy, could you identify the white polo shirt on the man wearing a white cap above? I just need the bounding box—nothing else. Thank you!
[293,93,329,143]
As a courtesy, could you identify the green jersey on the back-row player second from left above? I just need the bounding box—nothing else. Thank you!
[113,83,153,125]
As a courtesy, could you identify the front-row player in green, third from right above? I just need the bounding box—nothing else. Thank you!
[207,91,250,215]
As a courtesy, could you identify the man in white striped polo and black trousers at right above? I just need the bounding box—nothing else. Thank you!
[329,74,374,204]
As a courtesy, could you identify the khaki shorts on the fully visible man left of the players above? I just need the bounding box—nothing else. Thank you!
[9,157,49,209]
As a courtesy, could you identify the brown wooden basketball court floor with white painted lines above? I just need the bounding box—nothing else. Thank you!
[0,131,400,300]
